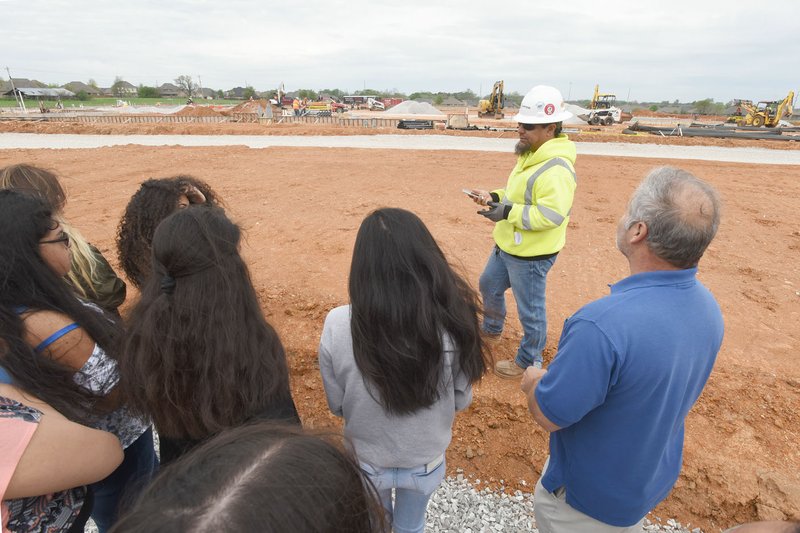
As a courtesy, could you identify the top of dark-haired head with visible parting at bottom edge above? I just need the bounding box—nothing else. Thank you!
[111,422,388,533]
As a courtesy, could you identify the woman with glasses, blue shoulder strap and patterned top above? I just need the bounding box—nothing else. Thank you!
[0,190,158,532]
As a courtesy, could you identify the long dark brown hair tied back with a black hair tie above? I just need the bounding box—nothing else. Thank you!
[119,206,291,439]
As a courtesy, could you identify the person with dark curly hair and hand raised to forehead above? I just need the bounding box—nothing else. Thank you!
[117,175,222,290]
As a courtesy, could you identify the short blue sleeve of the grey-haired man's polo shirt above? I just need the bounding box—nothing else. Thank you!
[535,318,619,428]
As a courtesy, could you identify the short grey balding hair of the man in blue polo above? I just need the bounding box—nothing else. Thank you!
[625,167,720,268]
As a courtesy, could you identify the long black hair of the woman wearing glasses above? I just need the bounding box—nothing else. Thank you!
[0,190,121,422]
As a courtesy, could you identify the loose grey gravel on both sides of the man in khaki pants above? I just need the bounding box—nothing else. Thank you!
[425,473,702,533]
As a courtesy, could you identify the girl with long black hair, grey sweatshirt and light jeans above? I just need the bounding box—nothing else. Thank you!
[319,208,486,532]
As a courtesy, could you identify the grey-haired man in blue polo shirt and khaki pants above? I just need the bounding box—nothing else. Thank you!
[521,167,723,533]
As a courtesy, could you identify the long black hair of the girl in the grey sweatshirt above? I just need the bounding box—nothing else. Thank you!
[349,208,486,414]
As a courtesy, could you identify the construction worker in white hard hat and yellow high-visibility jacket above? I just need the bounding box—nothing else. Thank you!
[465,85,577,378]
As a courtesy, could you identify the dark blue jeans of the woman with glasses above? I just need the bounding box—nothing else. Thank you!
[90,428,158,533]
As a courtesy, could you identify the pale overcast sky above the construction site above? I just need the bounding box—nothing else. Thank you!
[0,0,800,102]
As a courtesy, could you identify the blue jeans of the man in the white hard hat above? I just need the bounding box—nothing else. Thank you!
[479,246,556,368]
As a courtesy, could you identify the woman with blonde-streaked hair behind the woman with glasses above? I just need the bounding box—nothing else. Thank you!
[0,164,126,313]
